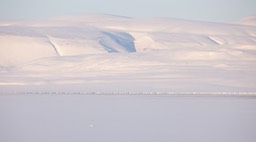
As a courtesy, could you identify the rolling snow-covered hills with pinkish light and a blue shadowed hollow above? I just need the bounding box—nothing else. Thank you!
[0,14,256,92]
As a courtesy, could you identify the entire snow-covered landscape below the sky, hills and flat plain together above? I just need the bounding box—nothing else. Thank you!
[0,14,256,142]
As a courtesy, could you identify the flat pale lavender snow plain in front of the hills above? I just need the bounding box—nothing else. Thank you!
[0,95,256,142]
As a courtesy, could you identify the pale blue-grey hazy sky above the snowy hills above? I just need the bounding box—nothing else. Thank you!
[0,0,256,22]
